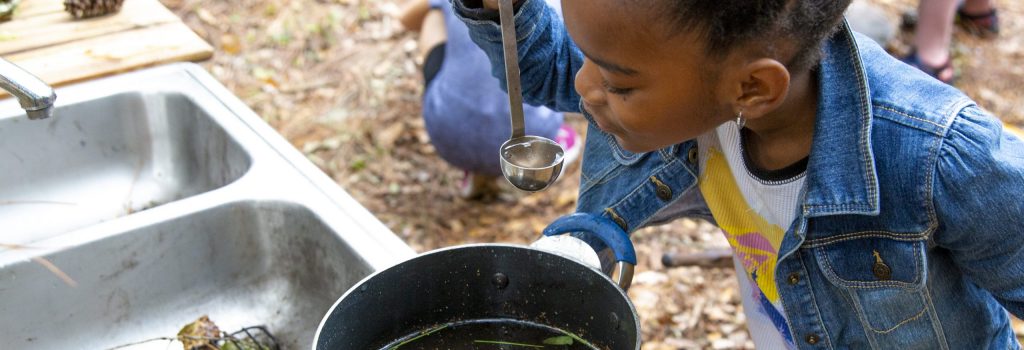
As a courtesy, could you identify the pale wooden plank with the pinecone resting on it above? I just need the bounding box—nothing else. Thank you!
[0,0,179,56]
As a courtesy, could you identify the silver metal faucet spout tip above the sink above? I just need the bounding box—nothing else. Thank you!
[0,58,57,119]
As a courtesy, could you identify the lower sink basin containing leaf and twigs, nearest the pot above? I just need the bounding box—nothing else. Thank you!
[0,202,374,349]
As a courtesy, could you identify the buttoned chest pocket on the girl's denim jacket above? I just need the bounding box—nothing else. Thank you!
[813,235,935,339]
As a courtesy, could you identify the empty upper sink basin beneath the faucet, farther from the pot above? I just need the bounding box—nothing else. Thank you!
[0,91,251,244]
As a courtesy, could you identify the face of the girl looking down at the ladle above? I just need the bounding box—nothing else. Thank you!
[562,0,735,151]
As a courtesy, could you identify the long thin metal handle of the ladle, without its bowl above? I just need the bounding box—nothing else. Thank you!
[498,0,526,139]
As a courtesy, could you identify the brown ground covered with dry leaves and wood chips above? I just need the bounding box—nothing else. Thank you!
[163,0,1024,350]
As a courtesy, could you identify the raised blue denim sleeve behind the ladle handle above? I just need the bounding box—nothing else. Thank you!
[451,0,583,113]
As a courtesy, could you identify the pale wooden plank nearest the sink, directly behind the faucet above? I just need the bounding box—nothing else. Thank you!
[5,20,213,86]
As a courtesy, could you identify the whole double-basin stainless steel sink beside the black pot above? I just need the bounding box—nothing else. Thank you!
[0,63,414,349]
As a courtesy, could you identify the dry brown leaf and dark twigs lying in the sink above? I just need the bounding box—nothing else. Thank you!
[109,315,281,350]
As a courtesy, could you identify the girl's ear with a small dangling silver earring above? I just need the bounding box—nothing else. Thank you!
[736,58,790,120]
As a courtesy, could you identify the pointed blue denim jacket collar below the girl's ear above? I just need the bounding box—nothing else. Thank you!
[803,21,879,217]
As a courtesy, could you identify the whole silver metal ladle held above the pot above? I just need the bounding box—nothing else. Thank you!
[498,0,565,192]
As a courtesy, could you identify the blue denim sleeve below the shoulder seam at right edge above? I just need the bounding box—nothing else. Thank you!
[934,103,1024,317]
